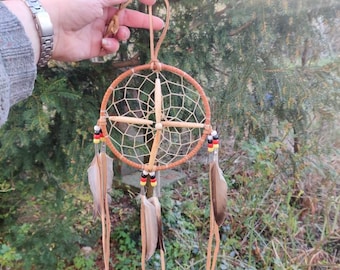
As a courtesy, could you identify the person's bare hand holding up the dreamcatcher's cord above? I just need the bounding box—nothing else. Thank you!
[41,0,164,61]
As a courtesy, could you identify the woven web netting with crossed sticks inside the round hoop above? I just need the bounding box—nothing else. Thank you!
[102,65,210,170]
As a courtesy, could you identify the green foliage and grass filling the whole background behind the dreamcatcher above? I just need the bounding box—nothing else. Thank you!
[0,0,340,269]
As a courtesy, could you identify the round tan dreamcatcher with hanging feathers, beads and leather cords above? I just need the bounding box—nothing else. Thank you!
[89,0,227,269]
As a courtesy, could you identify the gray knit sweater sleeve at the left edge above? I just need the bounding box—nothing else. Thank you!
[0,2,37,126]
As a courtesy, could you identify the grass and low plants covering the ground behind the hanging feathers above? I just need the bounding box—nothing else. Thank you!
[0,116,340,270]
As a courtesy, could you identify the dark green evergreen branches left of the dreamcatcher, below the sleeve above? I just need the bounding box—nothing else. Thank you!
[0,61,112,269]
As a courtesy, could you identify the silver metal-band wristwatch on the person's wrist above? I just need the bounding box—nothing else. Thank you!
[25,0,54,67]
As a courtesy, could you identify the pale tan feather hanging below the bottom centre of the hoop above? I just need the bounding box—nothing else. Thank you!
[141,195,158,260]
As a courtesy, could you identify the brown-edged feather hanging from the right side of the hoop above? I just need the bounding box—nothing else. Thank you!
[210,161,228,226]
